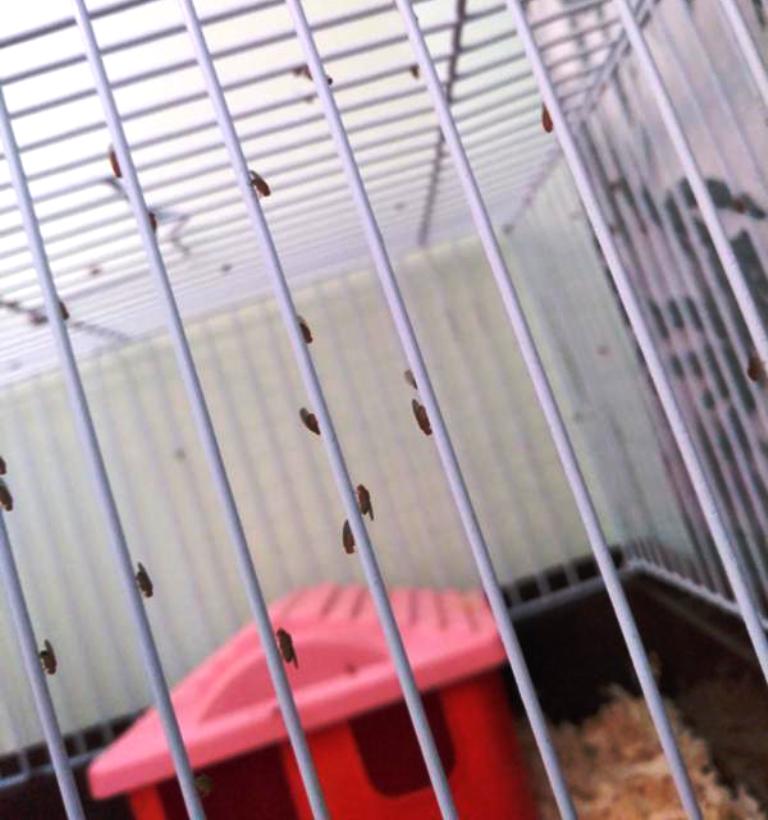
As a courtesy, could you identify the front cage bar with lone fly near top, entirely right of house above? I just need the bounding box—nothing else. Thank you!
[500,0,768,684]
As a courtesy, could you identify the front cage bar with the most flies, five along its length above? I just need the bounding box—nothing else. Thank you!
[179,0,457,818]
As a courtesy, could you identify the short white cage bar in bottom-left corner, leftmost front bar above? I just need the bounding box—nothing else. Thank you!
[0,516,85,820]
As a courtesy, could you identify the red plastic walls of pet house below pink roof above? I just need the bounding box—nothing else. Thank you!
[129,671,536,820]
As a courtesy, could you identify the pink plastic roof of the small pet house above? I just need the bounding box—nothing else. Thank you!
[88,584,504,797]
